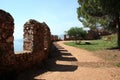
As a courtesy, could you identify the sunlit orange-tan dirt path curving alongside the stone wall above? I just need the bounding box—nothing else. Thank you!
[18,41,120,80]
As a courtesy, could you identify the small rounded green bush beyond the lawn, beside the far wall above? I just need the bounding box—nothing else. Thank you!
[67,27,86,39]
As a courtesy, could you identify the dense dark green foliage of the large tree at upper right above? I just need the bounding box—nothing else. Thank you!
[77,0,120,31]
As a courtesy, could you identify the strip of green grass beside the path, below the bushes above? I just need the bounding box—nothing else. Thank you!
[64,35,117,51]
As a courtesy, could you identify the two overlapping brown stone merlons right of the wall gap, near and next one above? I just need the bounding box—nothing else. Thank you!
[24,19,51,53]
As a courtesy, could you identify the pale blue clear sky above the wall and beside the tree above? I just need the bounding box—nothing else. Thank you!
[0,0,82,39]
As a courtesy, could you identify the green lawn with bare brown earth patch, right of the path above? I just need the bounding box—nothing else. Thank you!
[64,35,120,67]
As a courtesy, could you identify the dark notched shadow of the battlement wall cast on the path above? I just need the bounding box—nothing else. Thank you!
[18,43,78,80]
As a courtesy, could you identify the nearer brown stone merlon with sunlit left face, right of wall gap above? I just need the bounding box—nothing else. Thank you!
[24,19,45,52]
